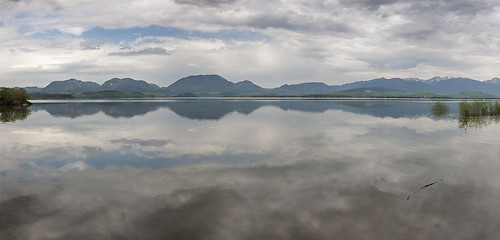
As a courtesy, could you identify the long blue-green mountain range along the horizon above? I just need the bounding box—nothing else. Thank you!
[25,75,500,96]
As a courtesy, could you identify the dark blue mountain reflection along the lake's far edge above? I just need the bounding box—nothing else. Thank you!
[31,100,438,120]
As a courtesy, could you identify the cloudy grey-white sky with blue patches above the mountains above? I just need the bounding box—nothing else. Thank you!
[0,0,500,87]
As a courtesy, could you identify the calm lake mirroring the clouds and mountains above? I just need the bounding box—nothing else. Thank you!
[0,99,500,239]
